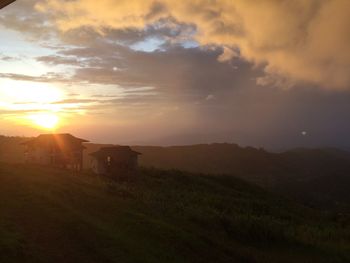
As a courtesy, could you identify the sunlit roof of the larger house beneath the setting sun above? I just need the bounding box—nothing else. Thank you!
[21,133,88,145]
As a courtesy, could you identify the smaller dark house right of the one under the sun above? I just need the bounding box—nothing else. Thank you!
[90,146,141,176]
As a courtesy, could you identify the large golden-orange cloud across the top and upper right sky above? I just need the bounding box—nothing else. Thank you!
[37,0,350,89]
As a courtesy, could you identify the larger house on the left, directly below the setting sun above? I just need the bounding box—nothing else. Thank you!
[22,133,88,171]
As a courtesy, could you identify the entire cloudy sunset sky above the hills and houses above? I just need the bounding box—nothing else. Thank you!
[0,0,350,149]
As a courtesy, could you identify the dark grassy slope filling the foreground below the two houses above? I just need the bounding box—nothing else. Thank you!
[0,164,350,263]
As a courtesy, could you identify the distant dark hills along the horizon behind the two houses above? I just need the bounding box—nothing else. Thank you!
[0,136,350,211]
